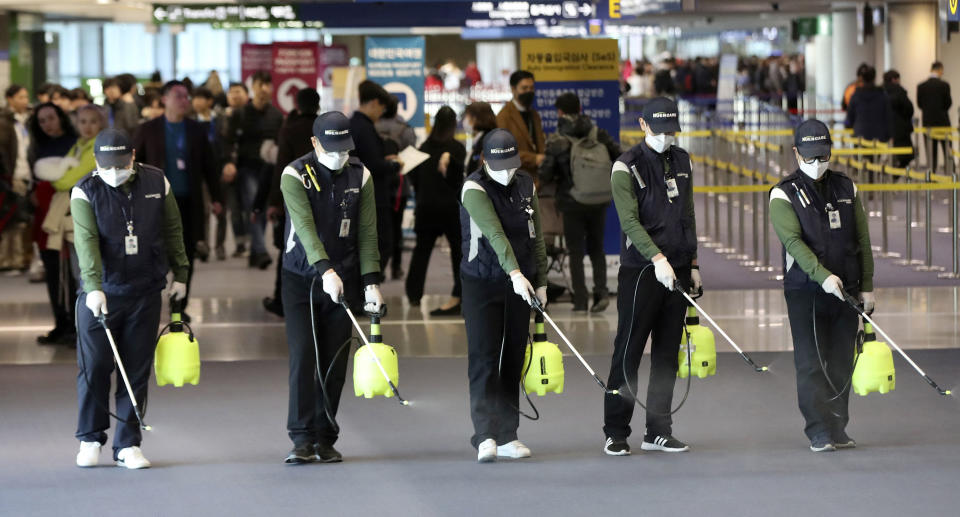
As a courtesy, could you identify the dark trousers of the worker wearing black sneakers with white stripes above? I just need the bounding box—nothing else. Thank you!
[603,265,690,440]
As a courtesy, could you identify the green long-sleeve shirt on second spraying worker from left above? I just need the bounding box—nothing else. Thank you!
[280,167,380,283]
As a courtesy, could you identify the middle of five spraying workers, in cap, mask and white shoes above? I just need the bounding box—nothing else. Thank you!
[460,129,547,463]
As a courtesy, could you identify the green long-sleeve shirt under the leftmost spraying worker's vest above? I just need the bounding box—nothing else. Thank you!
[70,171,189,293]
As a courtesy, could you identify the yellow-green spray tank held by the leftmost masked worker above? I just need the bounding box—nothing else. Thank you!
[153,300,200,388]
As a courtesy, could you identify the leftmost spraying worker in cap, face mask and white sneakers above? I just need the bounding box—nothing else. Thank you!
[70,129,188,469]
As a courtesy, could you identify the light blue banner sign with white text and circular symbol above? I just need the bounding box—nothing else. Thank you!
[366,36,426,127]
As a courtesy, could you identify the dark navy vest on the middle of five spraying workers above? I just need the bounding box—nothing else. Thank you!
[460,169,537,282]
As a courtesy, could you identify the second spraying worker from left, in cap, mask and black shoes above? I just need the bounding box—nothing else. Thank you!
[280,111,384,464]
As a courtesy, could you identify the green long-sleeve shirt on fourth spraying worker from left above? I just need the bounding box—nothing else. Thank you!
[610,156,697,264]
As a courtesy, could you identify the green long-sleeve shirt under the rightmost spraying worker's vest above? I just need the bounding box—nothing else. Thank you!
[770,177,873,292]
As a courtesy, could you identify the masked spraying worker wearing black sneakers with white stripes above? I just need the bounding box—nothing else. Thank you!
[603,97,703,456]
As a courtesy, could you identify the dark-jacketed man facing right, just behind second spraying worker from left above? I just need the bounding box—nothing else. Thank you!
[350,80,403,271]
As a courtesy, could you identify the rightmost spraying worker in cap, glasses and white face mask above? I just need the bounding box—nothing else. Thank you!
[770,119,876,452]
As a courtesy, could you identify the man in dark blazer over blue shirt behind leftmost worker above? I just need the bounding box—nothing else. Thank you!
[133,81,222,310]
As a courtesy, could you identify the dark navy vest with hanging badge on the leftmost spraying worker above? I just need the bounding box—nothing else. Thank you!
[77,163,169,296]
